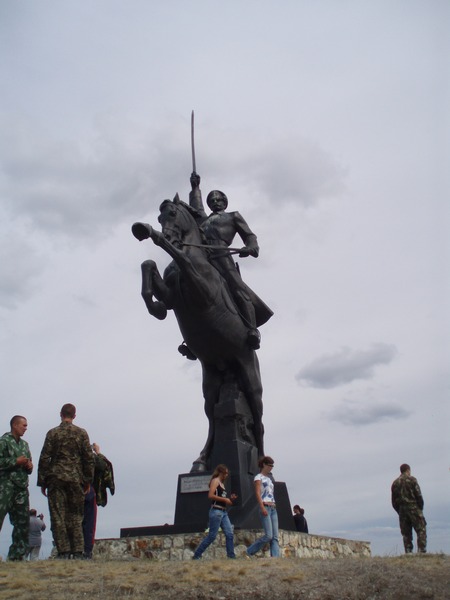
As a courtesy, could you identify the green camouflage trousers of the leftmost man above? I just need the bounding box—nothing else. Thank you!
[0,478,30,560]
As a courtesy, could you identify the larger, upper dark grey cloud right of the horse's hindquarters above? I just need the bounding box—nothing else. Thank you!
[295,343,397,389]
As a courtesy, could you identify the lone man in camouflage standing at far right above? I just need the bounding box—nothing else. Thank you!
[391,463,427,554]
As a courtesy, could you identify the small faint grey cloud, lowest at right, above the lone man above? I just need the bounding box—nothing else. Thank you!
[328,400,411,425]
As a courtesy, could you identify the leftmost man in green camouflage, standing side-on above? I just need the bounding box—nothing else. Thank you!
[0,415,33,560]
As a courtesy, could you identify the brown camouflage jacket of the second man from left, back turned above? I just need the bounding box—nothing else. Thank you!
[37,421,94,487]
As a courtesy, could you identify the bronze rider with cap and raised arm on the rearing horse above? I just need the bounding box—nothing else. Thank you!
[189,173,266,350]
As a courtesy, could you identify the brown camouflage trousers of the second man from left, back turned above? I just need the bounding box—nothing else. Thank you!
[47,481,84,554]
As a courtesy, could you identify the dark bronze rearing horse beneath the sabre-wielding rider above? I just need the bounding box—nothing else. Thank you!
[132,194,264,471]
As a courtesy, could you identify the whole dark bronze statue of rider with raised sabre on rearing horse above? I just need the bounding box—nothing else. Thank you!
[132,113,273,473]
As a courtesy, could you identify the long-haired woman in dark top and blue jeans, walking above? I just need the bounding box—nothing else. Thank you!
[192,465,237,560]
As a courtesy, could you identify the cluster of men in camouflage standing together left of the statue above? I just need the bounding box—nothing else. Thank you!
[0,404,115,561]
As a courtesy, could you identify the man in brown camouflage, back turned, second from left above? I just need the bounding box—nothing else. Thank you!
[38,404,94,559]
